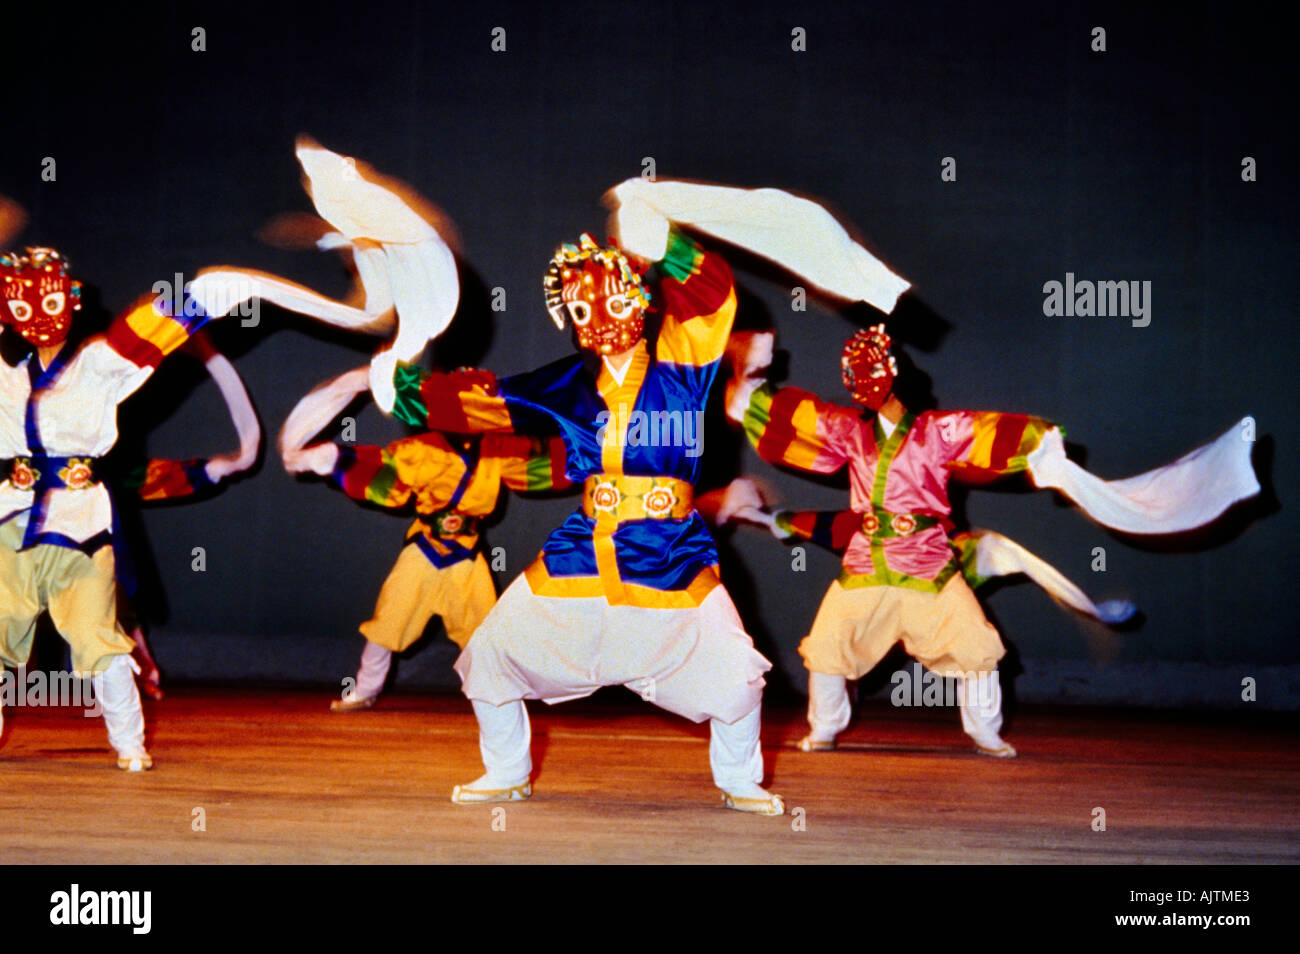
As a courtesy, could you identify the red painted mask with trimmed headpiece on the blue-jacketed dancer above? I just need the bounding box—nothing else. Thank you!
[542,234,650,355]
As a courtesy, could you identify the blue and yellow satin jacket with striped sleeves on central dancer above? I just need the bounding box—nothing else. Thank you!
[397,235,736,613]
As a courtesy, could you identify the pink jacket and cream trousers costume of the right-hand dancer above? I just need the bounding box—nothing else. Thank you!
[744,385,1049,754]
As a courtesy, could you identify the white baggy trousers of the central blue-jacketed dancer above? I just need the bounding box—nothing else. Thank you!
[456,576,771,797]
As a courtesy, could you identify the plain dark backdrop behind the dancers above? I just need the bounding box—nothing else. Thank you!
[0,1,1300,707]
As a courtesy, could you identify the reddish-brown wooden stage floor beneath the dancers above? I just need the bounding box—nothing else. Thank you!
[0,688,1300,864]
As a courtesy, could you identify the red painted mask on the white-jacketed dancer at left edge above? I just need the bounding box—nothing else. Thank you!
[0,248,81,347]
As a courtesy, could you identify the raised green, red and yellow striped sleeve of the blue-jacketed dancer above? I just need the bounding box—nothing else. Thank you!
[655,229,736,367]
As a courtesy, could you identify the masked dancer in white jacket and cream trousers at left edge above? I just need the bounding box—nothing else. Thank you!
[0,248,241,771]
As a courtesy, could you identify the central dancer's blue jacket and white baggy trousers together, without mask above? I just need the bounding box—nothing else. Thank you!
[395,227,770,801]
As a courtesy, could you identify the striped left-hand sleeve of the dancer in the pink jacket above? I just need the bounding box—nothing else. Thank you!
[742,382,853,473]
